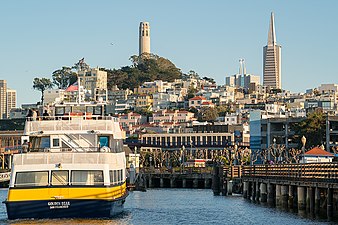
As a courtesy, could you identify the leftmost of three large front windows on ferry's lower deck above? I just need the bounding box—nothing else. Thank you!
[15,171,48,187]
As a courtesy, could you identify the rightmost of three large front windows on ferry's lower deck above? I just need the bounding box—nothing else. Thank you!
[71,170,103,185]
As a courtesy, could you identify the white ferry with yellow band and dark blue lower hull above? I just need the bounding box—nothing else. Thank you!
[4,104,128,219]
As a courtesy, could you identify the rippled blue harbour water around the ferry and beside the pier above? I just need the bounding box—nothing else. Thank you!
[0,189,330,225]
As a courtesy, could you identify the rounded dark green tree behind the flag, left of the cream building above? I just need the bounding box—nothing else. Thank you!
[52,66,77,89]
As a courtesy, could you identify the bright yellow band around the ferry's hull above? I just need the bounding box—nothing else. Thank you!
[7,183,127,202]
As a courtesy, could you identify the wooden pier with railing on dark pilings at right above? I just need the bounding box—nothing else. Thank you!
[213,162,338,220]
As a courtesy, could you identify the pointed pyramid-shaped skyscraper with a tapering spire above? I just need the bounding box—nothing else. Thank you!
[263,13,282,89]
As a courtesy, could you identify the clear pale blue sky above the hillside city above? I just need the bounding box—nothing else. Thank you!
[0,0,338,107]
